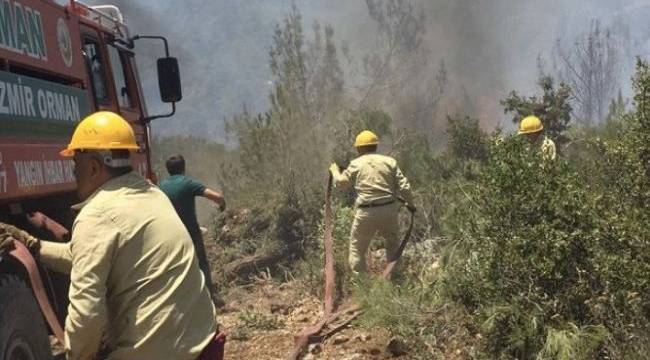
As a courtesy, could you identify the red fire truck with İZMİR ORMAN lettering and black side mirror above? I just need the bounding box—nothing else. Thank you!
[0,0,181,360]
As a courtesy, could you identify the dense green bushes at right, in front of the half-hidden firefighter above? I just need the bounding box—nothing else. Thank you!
[440,62,650,359]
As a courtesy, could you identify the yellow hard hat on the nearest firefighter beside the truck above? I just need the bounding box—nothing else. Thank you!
[60,111,139,157]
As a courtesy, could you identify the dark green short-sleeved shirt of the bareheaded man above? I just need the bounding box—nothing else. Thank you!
[160,175,205,237]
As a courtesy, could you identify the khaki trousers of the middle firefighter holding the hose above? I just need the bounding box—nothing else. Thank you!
[348,201,400,275]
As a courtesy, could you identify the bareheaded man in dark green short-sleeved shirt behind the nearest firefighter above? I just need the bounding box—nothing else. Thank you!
[160,155,226,296]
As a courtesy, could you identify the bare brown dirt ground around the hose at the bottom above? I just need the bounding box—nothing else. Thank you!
[218,279,406,360]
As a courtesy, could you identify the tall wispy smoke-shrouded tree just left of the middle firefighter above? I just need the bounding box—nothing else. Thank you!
[221,4,344,202]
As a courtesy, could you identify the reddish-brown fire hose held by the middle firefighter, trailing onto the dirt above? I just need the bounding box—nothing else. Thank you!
[287,173,415,360]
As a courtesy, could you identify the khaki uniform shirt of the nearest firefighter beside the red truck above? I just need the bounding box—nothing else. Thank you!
[41,173,216,360]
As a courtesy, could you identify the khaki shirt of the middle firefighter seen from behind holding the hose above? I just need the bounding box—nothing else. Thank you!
[332,153,413,206]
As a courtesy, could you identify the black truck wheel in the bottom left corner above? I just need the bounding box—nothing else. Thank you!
[0,274,52,360]
